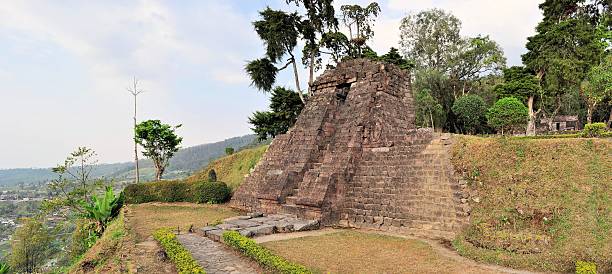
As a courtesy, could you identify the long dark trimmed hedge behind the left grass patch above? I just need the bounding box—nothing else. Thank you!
[123,181,231,204]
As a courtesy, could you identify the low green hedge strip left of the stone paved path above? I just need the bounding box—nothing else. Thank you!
[153,228,206,274]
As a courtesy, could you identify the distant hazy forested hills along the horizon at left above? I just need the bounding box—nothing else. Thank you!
[0,135,256,186]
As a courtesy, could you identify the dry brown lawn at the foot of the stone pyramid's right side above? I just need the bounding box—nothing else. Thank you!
[262,231,504,273]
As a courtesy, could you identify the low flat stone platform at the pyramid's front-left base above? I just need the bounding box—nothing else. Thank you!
[197,213,319,241]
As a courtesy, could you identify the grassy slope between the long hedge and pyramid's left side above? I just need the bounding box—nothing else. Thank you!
[187,145,268,190]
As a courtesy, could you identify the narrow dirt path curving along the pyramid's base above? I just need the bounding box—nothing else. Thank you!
[255,228,538,274]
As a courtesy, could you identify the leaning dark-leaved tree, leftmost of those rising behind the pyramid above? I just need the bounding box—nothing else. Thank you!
[246,8,305,103]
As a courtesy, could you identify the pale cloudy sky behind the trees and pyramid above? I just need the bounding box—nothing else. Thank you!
[0,0,542,169]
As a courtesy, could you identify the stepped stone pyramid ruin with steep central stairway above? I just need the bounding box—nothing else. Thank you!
[232,59,469,238]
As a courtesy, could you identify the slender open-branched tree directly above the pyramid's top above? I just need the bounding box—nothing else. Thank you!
[340,2,380,57]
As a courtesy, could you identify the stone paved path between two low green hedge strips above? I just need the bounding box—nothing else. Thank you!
[178,233,261,274]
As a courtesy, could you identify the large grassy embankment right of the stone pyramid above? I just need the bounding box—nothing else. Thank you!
[453,137,612,273]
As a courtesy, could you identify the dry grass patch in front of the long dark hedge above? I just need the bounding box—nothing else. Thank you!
[127,203,238,241]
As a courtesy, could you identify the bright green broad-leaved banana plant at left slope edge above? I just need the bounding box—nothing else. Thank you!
[82,186,124,235]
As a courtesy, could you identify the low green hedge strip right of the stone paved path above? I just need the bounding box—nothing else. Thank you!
[223,231,312,274]
